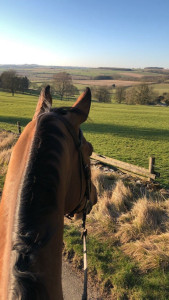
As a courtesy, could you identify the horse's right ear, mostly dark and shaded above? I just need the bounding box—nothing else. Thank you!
[72,88,91,125]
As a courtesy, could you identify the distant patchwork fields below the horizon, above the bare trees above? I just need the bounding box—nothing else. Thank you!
[0,65,169,100]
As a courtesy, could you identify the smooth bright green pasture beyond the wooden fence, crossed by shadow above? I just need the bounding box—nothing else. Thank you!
[0,92,169,186]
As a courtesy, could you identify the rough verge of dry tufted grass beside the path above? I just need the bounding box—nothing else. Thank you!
[0,131,169,300]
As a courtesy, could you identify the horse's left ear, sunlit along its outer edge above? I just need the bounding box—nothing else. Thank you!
[33,85,52,119]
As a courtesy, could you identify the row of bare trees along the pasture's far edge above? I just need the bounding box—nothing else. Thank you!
[0,70,169,105]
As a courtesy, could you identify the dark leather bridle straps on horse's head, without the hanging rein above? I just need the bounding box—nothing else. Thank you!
[57,114,92,218]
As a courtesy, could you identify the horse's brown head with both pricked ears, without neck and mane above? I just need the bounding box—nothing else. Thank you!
[33,86,97,216]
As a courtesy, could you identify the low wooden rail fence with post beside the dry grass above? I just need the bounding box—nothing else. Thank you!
[91,153,160,180]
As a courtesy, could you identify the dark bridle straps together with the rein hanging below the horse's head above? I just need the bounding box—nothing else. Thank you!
[57,115,91,300]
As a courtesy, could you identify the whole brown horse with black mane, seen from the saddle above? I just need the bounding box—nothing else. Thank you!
[0,86,97,300]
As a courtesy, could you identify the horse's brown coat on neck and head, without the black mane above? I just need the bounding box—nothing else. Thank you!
[0,87,96,300]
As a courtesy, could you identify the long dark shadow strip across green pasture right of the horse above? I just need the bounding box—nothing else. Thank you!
[82,123,169,141]
